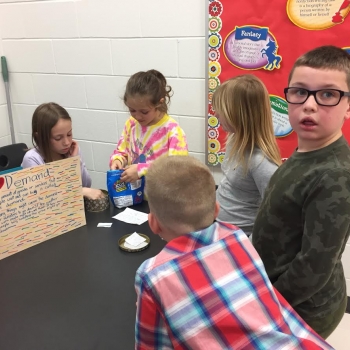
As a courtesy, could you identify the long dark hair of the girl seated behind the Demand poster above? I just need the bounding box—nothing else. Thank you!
[32,102,71,163]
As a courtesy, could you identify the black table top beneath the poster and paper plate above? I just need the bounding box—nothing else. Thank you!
[0,203,165,350]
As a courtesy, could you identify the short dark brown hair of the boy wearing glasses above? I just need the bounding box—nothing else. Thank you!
[288,45,350,89]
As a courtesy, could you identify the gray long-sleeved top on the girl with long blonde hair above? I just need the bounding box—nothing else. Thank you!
[216,149,277,236]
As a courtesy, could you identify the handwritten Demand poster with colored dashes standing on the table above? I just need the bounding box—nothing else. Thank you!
[0,157,86,259]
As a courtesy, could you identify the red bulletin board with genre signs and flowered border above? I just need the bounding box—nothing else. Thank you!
[208,0,350,165]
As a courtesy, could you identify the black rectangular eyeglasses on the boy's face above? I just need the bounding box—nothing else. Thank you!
[284,87,350,106]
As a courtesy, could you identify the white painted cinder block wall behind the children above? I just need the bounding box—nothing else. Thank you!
[0,0,350,294]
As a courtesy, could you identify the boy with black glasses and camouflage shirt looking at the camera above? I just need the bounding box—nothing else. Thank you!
[253,46,350,338]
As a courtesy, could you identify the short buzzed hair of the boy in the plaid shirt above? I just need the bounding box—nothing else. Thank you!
[146,156,216,233]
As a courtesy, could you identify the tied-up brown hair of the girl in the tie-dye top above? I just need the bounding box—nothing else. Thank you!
[124,69,172,113]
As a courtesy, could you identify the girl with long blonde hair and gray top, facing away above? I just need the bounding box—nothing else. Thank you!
[212,74,281,236]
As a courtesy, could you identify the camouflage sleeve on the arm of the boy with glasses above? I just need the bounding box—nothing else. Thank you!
[274,169,350,307]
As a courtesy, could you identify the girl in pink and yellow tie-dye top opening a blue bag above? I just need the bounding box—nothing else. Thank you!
[110,70,188,182]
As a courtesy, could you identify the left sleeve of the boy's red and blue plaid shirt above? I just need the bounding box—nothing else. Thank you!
[135,273,173,350]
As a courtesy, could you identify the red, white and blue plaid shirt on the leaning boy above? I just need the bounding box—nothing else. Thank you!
[135,223,332,350]
